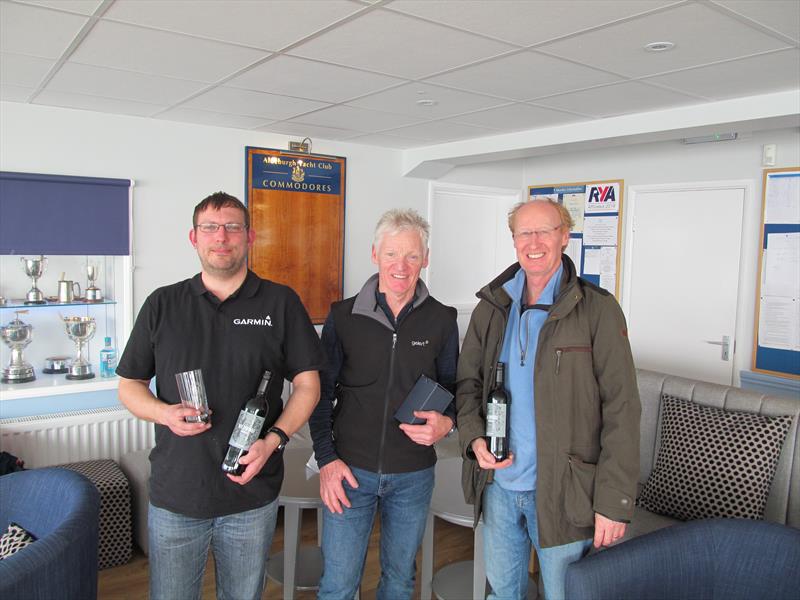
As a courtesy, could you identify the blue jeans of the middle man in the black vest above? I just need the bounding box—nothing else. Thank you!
[319,467,434,600]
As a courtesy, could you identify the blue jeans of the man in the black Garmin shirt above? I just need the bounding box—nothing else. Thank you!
[148,500,278,600]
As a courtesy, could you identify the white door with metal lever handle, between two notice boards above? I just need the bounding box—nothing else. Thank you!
[622,182,748,385]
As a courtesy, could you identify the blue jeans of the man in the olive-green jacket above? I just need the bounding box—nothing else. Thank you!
[483,483,592,600]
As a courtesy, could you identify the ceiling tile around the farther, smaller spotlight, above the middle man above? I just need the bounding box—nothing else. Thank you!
[348,83,505,120]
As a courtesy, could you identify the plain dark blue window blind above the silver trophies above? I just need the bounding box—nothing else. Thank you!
[0,171,131,255]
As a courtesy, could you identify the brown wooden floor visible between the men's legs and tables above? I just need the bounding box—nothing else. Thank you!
[98,510,473,600]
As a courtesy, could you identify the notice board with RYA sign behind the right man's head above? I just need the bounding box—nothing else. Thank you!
[528,179,624,299]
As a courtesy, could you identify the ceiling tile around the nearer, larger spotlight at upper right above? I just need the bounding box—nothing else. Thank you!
[537,4,786,77]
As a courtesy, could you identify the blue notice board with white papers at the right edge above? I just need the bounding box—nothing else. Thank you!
[753,167,800,379]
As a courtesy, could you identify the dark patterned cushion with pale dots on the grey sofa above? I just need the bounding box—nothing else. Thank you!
[637,394,792,521]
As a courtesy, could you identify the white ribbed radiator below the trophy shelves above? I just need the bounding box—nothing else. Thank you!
[0,407,155,468]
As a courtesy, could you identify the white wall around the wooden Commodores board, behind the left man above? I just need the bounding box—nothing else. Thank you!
[0,102,427,312]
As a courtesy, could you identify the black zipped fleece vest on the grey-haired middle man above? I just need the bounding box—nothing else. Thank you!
[331,297,456,473]
